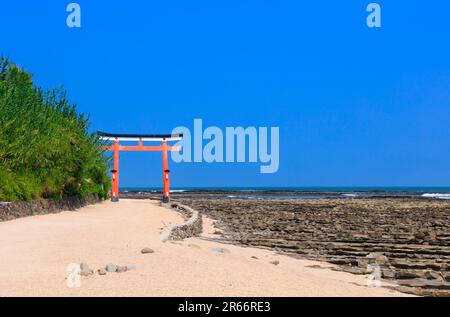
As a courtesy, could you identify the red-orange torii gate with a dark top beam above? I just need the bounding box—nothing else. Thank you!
[97,131,183,203]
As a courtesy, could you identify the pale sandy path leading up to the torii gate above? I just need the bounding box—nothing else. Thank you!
[0,200,408,296]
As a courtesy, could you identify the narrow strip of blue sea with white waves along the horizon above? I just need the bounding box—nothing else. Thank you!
[120,187,450,202]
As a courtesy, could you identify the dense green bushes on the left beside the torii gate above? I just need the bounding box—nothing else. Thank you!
[0,58,109,201]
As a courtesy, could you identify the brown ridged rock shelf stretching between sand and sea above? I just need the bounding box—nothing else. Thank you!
[180,198,450,296]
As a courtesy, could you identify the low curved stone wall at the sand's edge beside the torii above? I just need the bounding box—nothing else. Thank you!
[161,202,203,242]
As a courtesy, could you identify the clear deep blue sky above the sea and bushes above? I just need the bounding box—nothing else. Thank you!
[0,0,450,187]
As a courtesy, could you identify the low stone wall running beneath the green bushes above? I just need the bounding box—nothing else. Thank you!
[0,195,100,222]
